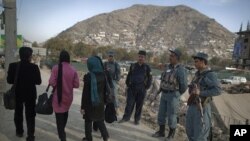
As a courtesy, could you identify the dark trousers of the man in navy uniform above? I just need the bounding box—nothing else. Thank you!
[123,87,146,121]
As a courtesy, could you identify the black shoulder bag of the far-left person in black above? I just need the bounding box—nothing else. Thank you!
[3,63,20,110]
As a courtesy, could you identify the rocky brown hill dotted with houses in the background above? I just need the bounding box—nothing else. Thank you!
[58,5,235,57]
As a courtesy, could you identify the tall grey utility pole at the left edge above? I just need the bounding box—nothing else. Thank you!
[3,0,17,91]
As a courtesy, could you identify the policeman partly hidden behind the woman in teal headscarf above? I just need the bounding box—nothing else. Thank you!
[104,51,121,113]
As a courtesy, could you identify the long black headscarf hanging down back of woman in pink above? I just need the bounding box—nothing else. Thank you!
[57,50,70,105]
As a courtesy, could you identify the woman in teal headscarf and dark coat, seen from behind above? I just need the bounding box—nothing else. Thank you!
[81,56,109,141]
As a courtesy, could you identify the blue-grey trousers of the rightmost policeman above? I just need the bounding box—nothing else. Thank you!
[186,104,211,141]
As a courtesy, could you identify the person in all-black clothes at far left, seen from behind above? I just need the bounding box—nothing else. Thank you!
[7,47,42,141]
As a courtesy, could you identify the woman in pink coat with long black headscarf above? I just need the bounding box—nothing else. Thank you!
[49,50,79,141]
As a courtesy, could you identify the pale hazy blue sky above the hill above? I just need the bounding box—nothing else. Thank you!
[0,0,250,42]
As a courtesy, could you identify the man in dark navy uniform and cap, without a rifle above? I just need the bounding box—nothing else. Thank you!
[119,50,152,125]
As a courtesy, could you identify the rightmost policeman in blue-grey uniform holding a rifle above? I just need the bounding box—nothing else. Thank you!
[186,52,221,141]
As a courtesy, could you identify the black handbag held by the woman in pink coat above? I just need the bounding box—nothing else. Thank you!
[35,85,55,115]
